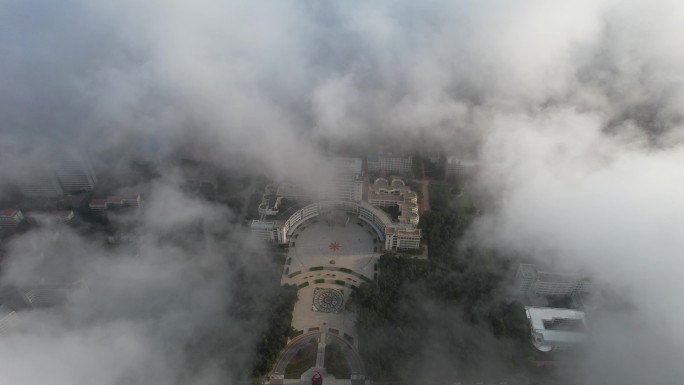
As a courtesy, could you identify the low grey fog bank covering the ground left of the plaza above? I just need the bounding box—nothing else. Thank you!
[0,180,278,385]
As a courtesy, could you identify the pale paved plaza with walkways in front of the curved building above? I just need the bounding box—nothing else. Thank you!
[269,213,374,385]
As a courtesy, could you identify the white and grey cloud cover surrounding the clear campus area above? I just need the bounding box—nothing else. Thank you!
[0,0,684,384]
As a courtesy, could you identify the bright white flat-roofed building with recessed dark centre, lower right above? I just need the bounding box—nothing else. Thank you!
[525,306,587,352]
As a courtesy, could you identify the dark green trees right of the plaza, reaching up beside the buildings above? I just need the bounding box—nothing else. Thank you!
[350,190,532,383]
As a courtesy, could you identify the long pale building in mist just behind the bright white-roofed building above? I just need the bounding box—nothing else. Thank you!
[515,263,592,295]
